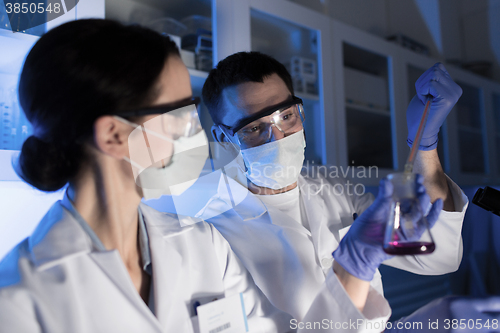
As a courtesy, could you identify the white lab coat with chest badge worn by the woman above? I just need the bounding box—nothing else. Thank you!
[0,195,390,333]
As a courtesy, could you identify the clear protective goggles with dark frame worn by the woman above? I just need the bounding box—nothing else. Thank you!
[119,97,202,140]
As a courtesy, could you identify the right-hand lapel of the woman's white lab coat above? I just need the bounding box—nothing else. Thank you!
[141,204,192,332]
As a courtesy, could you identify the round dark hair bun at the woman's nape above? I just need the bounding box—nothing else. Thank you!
[15,135,81,192]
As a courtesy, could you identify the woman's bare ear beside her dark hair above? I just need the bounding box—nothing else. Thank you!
[94,116,133,160]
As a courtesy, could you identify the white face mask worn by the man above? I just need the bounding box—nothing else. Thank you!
[241,130,306,190]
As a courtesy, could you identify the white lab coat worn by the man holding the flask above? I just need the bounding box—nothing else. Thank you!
[202,167,468,320]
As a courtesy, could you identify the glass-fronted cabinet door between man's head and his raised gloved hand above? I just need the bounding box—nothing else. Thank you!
[332,20,403,185]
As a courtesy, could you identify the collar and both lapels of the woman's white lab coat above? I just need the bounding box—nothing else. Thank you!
[28,195,189,331]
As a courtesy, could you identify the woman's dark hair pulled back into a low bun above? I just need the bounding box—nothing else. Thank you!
[16,19,179,191]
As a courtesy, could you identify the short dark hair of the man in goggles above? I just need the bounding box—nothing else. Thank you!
[202,52,294,124]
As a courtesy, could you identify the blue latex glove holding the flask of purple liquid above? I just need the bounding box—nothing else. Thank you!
[333,175,443,281]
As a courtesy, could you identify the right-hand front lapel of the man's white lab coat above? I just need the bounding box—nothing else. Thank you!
[298,176,338,270]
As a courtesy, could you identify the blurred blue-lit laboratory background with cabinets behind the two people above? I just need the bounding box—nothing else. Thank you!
[0,0,500,319]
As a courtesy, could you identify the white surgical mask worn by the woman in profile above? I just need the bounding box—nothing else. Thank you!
[116,113,209,200]
